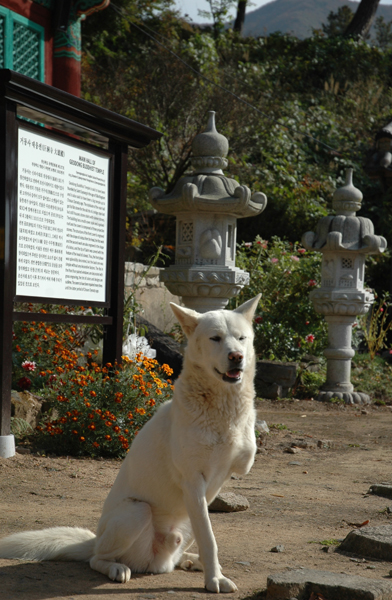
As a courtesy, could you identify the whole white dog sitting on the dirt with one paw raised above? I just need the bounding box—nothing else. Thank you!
[0,296,260,592]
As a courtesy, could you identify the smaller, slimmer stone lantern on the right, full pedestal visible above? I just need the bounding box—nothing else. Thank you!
[302,169,387,404]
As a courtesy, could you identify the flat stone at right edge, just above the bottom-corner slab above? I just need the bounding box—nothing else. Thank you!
[338,525,392,562]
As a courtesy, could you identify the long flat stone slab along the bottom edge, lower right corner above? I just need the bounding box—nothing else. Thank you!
[266,569,392,600]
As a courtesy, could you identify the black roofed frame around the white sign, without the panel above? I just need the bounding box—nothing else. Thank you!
[0,69,162,436]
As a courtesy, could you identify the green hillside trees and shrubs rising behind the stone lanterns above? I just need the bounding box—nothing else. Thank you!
[83,18,392,270]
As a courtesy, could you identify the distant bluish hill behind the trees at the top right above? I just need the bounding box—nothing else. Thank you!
[240,0,392,38]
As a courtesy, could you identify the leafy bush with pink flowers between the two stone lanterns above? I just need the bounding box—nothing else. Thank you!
[230,237,326,361]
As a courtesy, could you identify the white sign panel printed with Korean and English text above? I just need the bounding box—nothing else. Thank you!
[16,127,110,302]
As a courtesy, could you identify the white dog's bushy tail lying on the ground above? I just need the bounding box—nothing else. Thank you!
[0,527,95,561]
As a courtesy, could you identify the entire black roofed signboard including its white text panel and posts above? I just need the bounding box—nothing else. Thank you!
[0,69,161,457]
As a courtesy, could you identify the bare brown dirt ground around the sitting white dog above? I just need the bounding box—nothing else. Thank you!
[0,401,392,600]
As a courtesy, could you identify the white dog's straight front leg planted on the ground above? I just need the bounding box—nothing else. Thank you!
[182,473,237,593]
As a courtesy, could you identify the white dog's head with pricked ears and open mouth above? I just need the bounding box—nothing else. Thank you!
[171,294,261,384]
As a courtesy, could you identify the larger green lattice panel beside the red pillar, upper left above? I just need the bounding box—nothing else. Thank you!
[13,22,40,79]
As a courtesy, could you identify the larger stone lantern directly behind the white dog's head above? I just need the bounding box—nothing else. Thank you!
[150,111,267,312]
